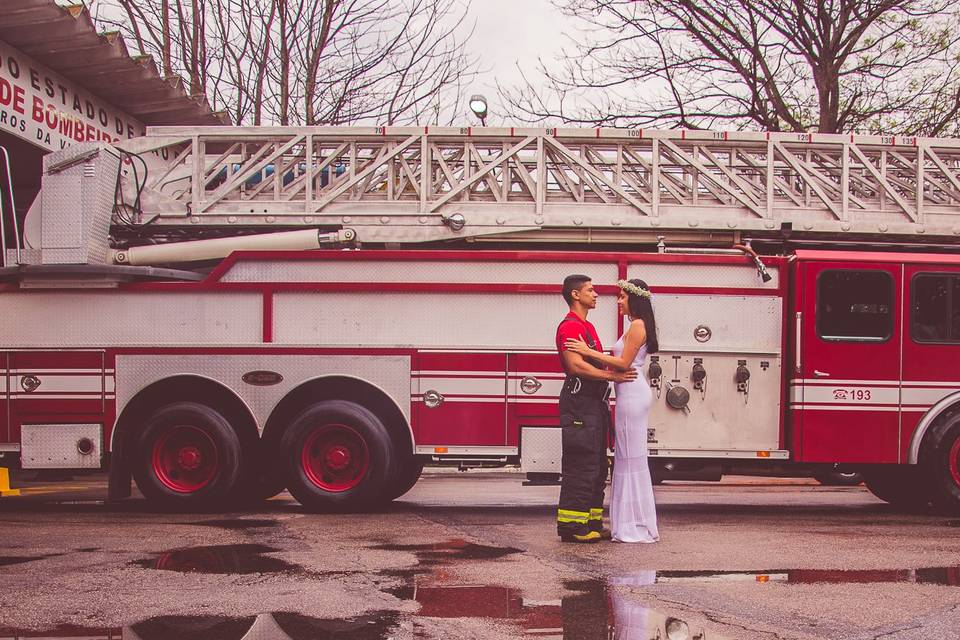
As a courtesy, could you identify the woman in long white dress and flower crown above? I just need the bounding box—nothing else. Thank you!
[567,280,660,542]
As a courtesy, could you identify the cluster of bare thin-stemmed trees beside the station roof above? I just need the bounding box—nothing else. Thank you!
[95,0,477,125]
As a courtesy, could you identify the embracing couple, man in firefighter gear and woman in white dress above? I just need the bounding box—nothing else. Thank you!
[557,275,659,543]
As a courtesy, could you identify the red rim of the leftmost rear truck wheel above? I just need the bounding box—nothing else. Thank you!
[153,425,219,493]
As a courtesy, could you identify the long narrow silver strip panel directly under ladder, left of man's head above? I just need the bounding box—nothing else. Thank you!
[223,260,617,284]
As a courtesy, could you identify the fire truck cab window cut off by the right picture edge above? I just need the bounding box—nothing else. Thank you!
[910,273,960,343]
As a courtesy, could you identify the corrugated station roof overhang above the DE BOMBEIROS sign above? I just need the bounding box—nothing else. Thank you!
[0,0,229,126]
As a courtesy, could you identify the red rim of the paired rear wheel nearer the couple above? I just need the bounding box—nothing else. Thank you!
[301,424,370,492]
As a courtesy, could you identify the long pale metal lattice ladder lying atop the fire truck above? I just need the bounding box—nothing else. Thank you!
[119,127,960,243]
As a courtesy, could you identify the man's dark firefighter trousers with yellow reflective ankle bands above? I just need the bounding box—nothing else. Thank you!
[557,389,610,536]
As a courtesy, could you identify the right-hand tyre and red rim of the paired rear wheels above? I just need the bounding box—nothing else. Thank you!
[280,400,393,511]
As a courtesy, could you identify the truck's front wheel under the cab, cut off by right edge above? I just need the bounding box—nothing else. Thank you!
[920,407,960,513]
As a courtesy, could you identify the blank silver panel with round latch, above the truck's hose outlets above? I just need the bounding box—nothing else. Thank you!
[653,294,783,354]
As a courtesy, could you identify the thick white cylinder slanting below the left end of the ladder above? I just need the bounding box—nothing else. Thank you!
[113,229,356,266]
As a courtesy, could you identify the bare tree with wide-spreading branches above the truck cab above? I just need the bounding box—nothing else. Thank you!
[500,0,960,135]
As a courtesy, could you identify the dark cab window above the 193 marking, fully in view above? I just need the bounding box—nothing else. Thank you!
[817,269,893,342]
